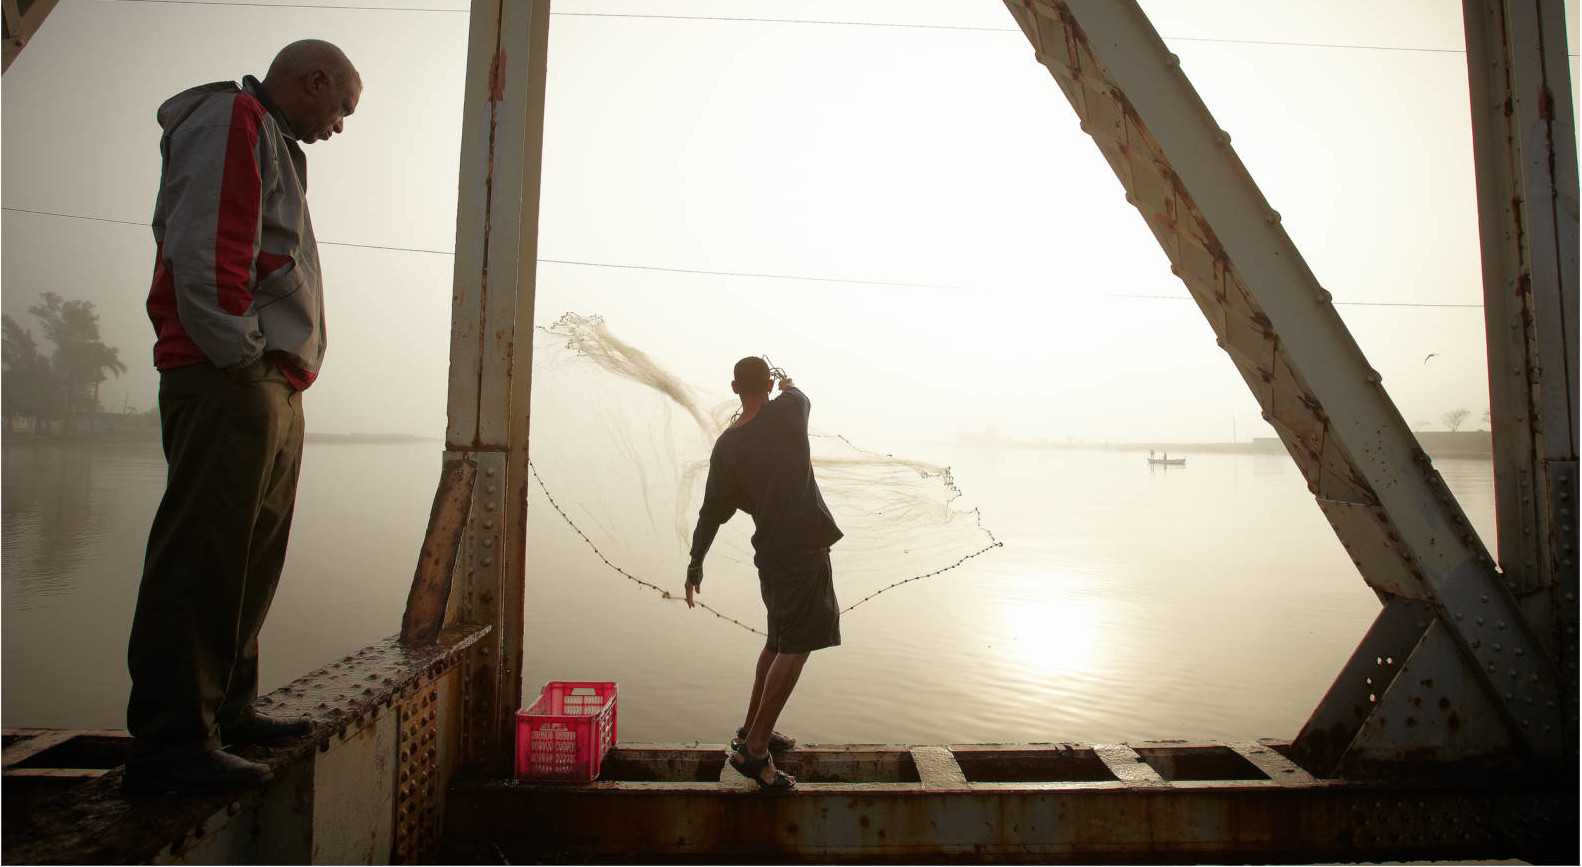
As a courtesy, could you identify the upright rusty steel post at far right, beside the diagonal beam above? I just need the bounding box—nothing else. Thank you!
[1462,0,1579,756]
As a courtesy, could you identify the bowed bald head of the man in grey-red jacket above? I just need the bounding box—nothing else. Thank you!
[263,40,362,144]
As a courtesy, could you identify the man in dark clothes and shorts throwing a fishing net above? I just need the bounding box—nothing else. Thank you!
[687,356,842,789]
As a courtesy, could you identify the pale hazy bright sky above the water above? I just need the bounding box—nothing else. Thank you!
[3,0,1577,446]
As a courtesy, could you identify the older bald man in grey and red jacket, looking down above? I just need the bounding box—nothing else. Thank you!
[125,40,362,794]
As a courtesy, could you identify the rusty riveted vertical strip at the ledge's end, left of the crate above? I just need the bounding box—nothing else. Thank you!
[391,680,443,864]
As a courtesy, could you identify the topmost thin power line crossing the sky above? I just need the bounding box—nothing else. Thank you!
[100,0,1576,57]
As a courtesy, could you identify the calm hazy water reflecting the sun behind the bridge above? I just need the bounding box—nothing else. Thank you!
[0,441,1493,744]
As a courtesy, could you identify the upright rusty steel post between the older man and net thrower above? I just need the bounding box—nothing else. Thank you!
[442,0,549,775]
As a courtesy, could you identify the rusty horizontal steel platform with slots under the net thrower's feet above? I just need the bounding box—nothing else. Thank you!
[441,740,1577,862]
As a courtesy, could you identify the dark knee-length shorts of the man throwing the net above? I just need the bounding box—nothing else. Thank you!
[758,547,840,653]
